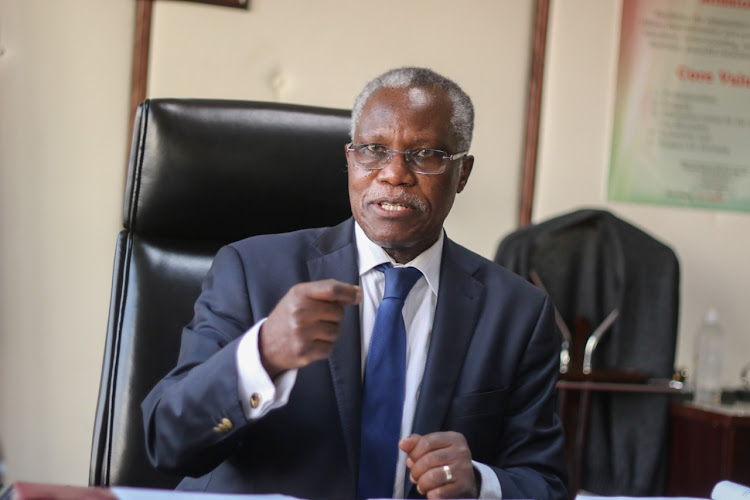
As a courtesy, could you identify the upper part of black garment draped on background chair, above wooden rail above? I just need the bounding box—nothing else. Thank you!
[495,209,679,378]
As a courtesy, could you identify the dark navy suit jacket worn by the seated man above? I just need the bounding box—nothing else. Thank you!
[143,219,566,499]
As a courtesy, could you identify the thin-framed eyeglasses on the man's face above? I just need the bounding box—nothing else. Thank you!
[346,142,469,175]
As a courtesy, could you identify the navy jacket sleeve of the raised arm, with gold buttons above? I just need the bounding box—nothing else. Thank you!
[142,247,254,476]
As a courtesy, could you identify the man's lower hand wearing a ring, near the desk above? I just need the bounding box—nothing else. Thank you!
[399,432,478,498]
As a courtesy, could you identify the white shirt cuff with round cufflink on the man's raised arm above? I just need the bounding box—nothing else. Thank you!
[235,318,297,420]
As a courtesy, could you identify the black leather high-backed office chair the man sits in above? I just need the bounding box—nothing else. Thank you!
[89,99,351,488]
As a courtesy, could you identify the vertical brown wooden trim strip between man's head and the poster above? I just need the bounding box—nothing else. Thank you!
[518,0,549,227]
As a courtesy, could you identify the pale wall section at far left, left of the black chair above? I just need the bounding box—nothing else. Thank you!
[0,0,135,484]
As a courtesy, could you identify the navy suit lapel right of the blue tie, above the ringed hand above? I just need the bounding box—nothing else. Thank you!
[404,238,484,496]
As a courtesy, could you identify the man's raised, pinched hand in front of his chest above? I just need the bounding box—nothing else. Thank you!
[258,279,362,378]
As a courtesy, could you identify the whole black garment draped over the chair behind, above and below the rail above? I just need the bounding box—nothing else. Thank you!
[495,210,680,497]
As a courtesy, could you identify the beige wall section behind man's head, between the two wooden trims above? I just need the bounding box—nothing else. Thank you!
[148,0,533,256]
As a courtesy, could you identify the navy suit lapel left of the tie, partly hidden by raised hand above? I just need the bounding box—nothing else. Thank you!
[307,219,362,474]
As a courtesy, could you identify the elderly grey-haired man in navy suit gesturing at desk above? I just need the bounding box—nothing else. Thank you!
[143,68,566,499]
